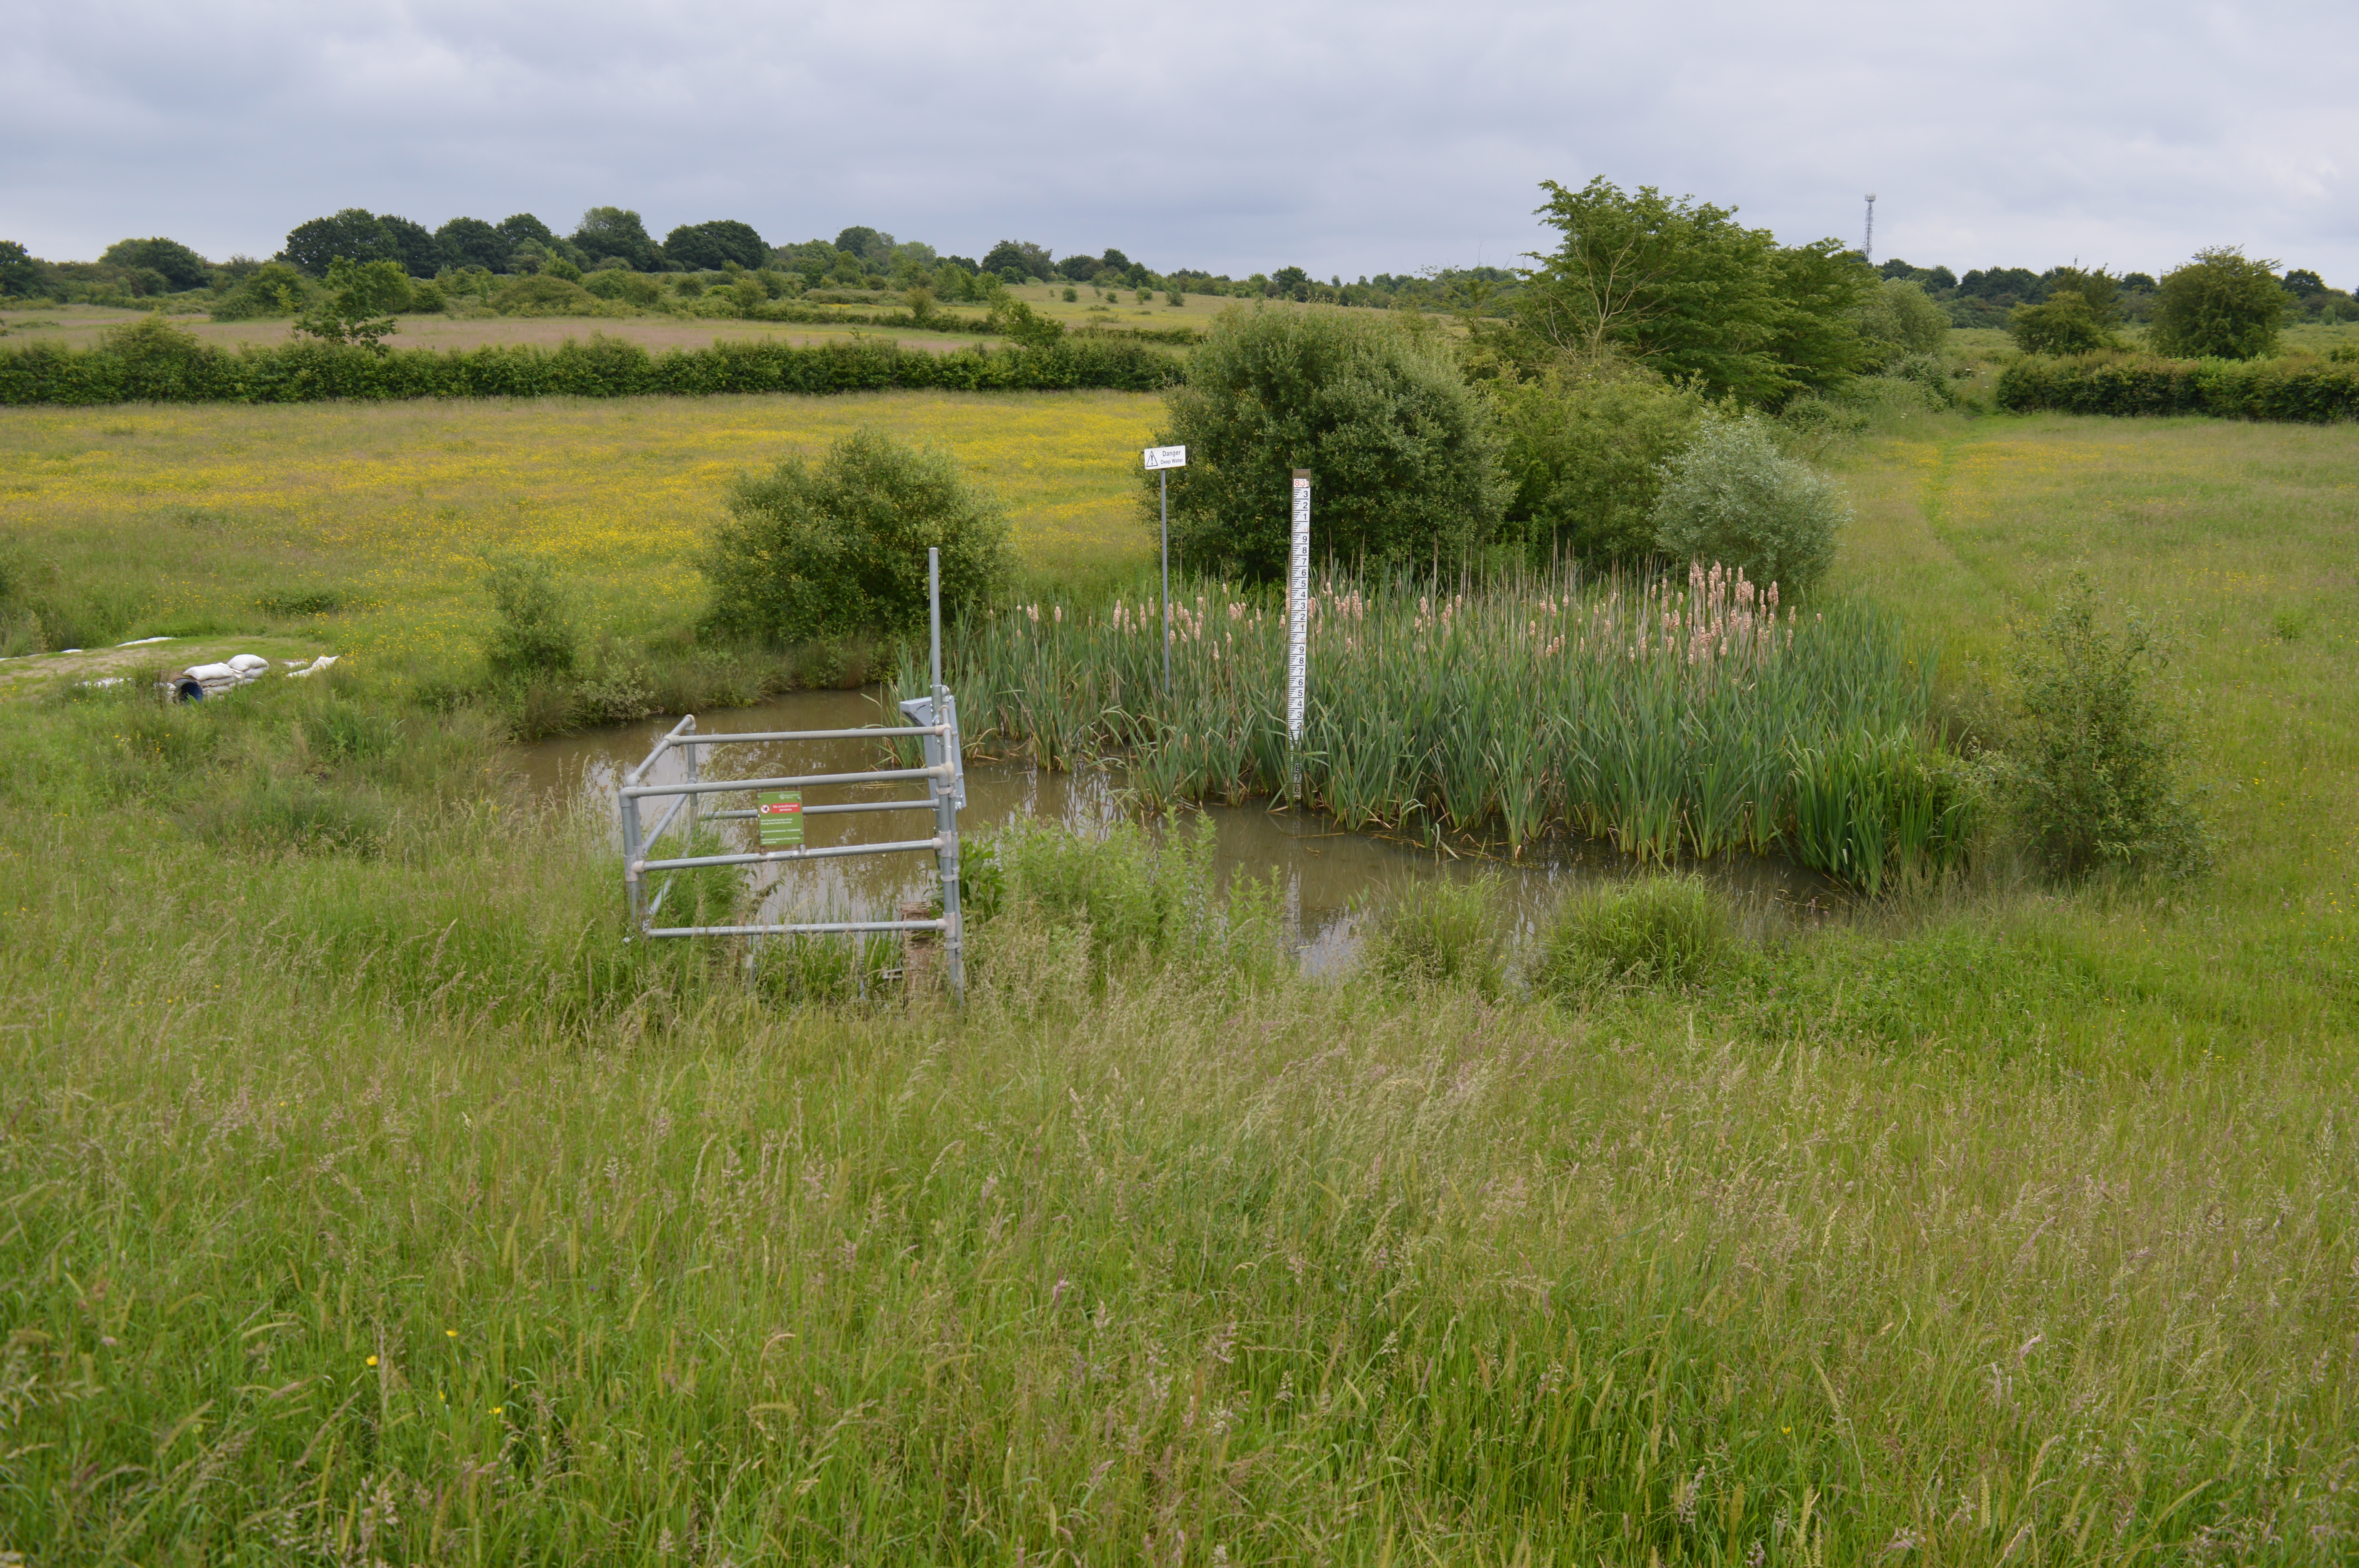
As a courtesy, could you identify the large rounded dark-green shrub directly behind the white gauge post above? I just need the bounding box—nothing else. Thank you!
[1142,307,1507,580]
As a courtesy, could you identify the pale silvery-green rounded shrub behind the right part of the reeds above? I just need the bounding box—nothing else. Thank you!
[1654,413,1852,592]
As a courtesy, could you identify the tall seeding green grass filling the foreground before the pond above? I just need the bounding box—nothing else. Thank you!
[0,691,2359,1568]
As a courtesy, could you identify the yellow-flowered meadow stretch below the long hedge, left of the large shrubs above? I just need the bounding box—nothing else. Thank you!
[0,394,1161,672]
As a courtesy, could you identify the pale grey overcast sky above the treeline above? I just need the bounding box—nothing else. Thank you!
[0,0,2359,288]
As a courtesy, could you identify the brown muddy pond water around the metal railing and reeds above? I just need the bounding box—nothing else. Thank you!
[519,688,1850,969]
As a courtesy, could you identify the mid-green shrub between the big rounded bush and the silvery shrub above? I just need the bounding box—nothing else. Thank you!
[1493,370,1706,564]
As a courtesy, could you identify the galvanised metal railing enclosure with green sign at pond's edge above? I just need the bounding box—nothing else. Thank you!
[620,550,967,1000]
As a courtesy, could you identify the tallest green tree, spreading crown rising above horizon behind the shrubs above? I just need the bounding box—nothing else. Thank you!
[1514,177,1878,406]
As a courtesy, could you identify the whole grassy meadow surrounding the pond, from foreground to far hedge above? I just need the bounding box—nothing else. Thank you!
[0,394,2359,1568]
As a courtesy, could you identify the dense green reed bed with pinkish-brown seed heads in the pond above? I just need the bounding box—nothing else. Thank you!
[903,566,1977,894]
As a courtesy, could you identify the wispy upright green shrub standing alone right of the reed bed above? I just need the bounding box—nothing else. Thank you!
[2001,578,2210,877]
